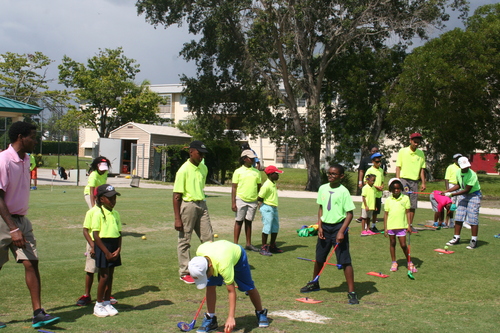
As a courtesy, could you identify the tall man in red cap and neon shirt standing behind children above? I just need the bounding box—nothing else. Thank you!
[396,133,426,232]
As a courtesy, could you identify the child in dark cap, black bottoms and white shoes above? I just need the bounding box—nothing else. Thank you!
[92,184,122,317]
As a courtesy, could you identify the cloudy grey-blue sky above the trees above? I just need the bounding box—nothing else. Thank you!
[0,0,499,84]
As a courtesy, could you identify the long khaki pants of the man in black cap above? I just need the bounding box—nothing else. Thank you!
[177,201,214,276]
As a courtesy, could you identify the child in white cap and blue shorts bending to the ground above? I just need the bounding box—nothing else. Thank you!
[188,240,269,332]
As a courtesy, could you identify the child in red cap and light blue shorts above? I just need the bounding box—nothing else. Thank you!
[257,165,283,256]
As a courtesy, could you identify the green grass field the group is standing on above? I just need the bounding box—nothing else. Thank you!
[0,186,500,333]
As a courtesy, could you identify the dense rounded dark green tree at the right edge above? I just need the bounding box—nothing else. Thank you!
[389,4,500,175]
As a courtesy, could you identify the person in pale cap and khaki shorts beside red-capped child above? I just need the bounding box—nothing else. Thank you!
[231,149,262,252]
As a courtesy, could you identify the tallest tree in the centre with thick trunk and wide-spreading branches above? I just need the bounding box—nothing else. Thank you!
[137,0,467,191]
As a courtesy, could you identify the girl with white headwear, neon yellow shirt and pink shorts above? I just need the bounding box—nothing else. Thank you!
[384,178,417,273]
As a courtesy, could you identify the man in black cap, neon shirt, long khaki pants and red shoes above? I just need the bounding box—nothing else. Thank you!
[172,141,214,284]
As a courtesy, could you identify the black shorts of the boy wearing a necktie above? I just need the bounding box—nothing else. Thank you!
[316,221,351,265]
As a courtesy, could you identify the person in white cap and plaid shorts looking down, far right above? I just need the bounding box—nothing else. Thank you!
[444,156,483,250]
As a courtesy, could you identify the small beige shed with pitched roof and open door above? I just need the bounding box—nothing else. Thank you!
[108,122,192,178]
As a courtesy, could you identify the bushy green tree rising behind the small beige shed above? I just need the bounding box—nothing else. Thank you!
[59,48,163,138]
